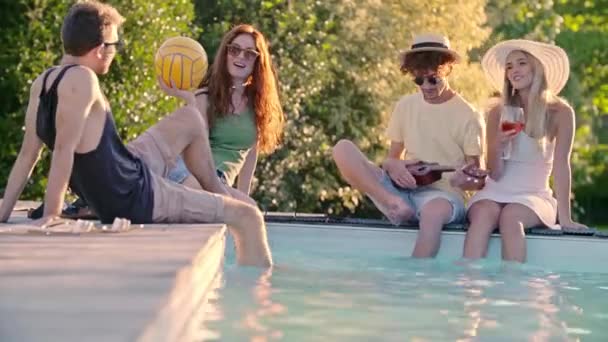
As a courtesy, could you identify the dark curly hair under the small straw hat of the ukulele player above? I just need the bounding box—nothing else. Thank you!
[400,51,456,76]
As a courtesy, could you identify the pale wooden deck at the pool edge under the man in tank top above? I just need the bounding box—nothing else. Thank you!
[0,203,225,342]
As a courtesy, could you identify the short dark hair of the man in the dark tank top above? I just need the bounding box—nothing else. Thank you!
[61,1,125,56]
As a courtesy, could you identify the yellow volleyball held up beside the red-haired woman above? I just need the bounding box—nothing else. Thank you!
[154,37,209,90]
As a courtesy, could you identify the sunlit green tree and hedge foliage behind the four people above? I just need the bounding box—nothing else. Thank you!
[0,0,608,221]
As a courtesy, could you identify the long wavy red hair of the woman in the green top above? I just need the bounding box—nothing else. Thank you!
[201,24,285,153]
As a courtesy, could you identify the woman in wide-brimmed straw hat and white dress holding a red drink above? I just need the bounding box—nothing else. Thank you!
[464,39,586,262]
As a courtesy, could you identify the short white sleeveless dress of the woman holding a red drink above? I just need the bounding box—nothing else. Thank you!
[468,131,560,229]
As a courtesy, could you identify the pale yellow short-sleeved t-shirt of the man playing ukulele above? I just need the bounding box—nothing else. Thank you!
[386,92,485,198]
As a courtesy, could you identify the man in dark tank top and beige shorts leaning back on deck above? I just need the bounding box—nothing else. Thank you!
[0,1,272,266]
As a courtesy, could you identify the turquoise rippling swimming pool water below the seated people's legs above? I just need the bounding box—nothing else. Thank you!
[202,228,608,341]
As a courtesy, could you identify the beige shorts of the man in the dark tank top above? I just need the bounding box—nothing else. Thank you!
[127,124,224,223]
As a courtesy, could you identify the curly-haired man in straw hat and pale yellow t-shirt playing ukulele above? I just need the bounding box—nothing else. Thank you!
[333,34,483,257]
